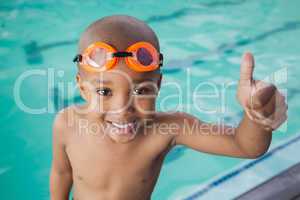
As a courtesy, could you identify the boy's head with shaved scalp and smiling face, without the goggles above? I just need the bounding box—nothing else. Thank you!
[77,16,161,143]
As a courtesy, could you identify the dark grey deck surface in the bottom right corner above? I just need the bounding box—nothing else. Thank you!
[235,163,300,200]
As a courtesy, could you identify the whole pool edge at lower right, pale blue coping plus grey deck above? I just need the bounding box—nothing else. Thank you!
[182,132,300,200]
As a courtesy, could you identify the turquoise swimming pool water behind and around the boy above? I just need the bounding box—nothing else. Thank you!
[0,0,300,199]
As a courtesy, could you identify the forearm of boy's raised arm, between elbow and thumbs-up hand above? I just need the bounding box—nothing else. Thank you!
[234,114,272,158]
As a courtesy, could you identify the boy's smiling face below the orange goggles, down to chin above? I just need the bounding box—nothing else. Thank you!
[77,59,162,143]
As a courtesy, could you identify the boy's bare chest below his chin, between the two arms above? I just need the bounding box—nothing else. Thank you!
[67,136,166,189]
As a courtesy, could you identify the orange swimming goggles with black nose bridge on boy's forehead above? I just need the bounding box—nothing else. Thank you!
[73,42,163,72]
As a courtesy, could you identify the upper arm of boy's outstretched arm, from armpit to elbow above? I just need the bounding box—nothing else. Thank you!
[174,113,246,157]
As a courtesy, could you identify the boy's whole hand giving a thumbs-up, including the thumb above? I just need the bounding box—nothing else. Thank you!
[237,53,287,130]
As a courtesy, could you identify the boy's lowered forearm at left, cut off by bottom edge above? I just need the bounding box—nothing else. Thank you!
[50,169,73,200]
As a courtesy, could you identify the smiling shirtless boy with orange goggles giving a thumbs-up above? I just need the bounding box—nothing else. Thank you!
[50,16,287,200]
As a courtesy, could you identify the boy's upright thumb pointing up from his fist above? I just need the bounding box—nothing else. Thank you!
[240,52,254,84]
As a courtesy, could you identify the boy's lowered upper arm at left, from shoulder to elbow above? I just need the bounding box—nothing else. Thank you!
[52,112,72,174]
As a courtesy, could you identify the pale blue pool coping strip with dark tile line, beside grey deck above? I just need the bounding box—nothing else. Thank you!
[183,133,300,200]
